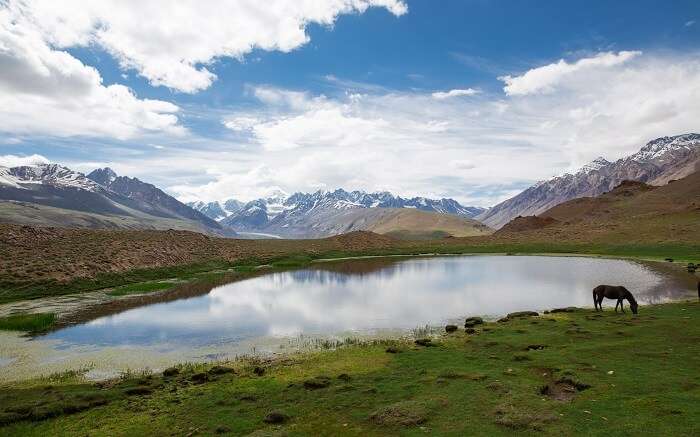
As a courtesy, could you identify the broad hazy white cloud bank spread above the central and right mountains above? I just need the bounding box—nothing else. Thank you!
[185,54,700,206]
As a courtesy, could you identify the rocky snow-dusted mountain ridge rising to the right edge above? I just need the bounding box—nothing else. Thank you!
[476,133,700,228]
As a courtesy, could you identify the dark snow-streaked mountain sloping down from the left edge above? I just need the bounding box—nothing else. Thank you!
[0,164,232,234]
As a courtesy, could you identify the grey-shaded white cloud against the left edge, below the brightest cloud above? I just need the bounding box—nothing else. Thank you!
[0,3,184,139]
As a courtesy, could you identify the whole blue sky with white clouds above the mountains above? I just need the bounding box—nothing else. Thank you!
[0,0,700,206]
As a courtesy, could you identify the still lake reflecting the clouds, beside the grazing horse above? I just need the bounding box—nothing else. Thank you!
[0,256,693,378]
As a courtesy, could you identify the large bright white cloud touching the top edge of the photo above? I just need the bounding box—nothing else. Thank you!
[10,0,408,93]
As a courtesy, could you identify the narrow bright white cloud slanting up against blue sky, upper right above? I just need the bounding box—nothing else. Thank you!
[499,51,641,96]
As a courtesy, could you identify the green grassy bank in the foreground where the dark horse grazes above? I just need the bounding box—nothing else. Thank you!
[0,302,700,436]
